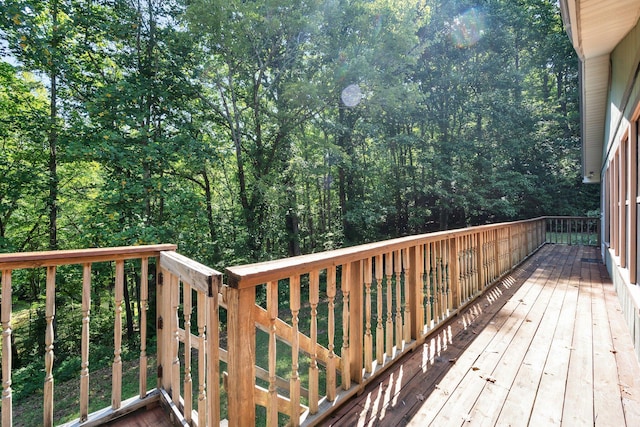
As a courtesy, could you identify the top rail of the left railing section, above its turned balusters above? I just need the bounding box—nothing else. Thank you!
[0,244,177,270]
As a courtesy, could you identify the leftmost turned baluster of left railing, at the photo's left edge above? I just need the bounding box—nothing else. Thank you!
[0,270,13,426]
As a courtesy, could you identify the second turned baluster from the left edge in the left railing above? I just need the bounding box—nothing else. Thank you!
[43,266,56,427]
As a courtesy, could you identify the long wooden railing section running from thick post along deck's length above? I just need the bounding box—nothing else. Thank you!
[225,218,546,426]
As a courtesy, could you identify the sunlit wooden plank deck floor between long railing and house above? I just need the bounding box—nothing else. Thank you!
[329,245,640,426]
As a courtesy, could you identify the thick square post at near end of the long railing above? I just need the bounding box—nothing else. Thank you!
[225,286,255,427]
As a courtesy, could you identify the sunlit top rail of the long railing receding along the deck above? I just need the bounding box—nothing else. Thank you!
[225,217,545,289]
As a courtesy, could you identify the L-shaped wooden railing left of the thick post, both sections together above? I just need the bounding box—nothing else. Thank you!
[0,245,222,426]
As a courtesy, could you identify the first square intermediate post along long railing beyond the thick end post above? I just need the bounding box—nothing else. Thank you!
[345,261,364,384]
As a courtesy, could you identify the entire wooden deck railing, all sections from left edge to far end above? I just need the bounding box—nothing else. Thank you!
[0,217,598,426]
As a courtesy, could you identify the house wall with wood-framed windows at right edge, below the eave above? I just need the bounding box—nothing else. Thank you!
[601,19,640,359]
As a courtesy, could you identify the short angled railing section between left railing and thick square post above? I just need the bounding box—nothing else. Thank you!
[157,252,222,426]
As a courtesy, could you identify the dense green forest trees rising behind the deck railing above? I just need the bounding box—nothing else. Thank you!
[0,0,598,268]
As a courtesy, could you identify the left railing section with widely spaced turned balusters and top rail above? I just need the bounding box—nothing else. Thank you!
[0,244,176,426]
